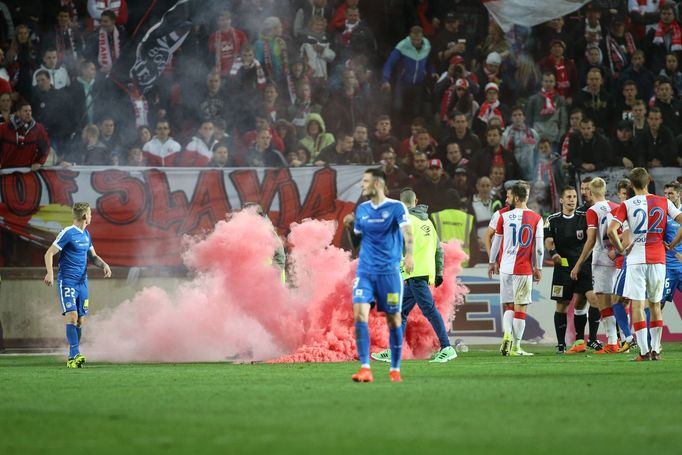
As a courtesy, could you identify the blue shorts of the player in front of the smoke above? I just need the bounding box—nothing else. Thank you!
[353,270,403,313]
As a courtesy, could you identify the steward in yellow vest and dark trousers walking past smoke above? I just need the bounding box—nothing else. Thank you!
[372,188,457,363]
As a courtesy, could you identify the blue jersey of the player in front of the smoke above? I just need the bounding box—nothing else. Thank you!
[353,199,410,275]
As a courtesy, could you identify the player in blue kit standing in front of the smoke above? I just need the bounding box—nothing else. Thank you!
[344,169,414,382]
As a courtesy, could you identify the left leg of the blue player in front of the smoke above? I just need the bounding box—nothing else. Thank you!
[352,276,374,382]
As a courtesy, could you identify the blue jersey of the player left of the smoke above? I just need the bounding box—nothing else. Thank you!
[52,226,92,283]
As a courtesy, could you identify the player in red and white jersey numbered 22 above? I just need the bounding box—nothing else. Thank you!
[608,167,682,361]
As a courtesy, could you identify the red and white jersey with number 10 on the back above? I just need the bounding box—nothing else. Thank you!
[495,209,544,275]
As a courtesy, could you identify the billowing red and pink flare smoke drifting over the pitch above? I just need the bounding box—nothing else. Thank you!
[84,212,466,362]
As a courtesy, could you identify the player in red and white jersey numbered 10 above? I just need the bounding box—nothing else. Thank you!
[488,182,544,356]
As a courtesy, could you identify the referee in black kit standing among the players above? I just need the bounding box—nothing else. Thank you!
[545,186,592,354]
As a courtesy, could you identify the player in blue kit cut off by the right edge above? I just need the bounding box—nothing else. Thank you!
[661,182,682,324]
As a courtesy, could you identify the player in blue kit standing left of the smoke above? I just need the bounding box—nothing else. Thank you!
[44,202,111,368]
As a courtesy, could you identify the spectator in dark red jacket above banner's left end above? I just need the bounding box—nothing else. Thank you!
[0,103,50,171]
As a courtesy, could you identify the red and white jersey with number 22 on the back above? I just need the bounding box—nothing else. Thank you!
[613,194,681,265]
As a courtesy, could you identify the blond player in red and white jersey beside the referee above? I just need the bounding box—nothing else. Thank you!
[571,177,619,354]
